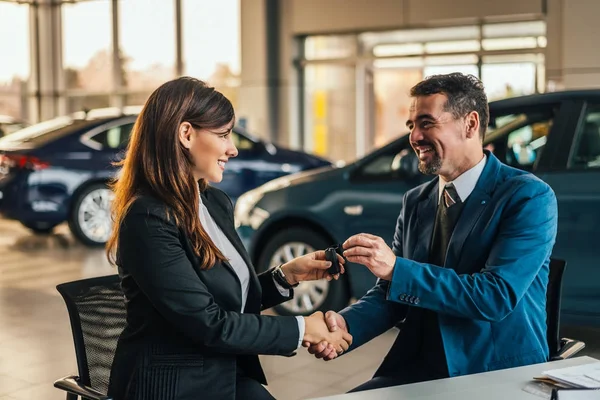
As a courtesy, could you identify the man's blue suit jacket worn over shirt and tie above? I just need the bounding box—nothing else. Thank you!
[341,152,558,377]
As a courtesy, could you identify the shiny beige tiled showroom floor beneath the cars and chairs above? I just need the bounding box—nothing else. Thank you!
[0,220,600,400]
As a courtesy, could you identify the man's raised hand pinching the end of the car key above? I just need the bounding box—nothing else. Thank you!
[343,233,396,281]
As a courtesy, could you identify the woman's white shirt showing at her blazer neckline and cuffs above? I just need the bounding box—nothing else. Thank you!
[200,197,305,347]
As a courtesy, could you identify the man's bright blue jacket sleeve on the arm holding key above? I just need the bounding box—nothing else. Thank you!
[388,180,558,322]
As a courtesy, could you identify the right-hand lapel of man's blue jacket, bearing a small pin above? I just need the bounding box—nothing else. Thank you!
[444,151,500,272]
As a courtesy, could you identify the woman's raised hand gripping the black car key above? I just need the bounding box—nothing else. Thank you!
[281,250,344,285]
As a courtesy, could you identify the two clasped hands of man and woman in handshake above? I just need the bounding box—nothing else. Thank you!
[302,311,352,361]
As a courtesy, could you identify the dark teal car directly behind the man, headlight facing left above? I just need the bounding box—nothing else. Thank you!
[236,90,600,326]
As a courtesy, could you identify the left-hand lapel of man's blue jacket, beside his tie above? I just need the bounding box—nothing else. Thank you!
[409,184,439,262]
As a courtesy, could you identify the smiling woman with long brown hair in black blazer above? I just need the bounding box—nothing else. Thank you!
[107,77,352,400]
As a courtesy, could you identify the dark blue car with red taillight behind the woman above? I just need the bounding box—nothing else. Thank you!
[0,107,330,246]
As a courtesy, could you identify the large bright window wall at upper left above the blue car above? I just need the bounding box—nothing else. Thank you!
[0,0,241,120]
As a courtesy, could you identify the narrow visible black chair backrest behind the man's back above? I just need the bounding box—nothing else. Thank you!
[546,258,567,357]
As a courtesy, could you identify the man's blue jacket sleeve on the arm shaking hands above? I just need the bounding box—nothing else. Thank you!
[340,194,408,350]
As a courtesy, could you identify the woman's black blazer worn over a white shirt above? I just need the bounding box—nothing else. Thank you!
[109,187,299,400]
